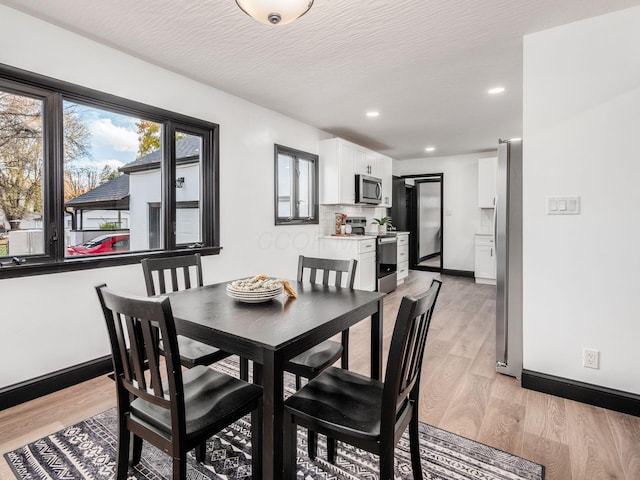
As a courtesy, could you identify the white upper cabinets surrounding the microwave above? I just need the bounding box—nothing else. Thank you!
[320,138,392,207]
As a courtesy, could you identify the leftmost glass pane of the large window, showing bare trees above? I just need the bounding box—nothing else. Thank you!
[0,90,44,257]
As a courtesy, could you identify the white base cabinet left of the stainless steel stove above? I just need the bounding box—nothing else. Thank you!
[318,236,376,292]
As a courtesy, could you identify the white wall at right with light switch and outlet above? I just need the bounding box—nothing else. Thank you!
[523,7,640,394]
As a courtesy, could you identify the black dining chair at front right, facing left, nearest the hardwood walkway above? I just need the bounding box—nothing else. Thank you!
[284,280,442,480]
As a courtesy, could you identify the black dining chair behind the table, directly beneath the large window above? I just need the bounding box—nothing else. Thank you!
[141,253,249,380]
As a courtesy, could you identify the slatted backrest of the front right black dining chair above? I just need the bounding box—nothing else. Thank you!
[382,280,442,419]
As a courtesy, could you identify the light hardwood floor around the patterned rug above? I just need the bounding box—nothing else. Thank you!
[0,271,640,480]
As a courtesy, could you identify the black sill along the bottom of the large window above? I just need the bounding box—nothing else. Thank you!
[0,247,222,280]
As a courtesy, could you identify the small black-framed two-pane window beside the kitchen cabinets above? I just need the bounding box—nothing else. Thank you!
[275,145,318,225]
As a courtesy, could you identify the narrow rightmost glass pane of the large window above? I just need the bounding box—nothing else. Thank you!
[175,132,202,245]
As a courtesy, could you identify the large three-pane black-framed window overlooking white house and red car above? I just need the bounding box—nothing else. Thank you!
[0,66,220,277]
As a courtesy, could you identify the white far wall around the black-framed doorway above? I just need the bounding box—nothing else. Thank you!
[393,152,497,272]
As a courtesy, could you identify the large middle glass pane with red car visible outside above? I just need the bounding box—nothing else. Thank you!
[63,101,162,256]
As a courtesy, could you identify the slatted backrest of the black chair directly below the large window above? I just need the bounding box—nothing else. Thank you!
[141,253,204,296]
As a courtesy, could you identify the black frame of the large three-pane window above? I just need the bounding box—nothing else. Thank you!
[0,64,222,279]
